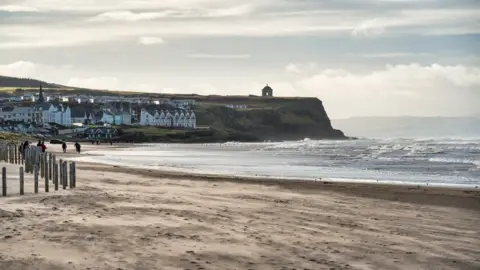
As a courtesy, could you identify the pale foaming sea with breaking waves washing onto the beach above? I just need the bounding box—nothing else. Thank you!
[71,119,480,188]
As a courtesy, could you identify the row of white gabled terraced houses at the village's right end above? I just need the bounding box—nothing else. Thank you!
[140,109,197,128]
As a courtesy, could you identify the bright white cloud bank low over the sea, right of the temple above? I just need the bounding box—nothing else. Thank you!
[293,64,480,117]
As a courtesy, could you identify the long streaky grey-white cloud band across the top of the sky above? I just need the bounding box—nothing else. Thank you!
[0,0,480,48]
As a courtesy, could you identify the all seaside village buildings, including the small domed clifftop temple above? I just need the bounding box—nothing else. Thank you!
[0,85,273,137]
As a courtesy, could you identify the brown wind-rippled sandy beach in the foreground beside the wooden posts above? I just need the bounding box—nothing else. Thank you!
[0,144,480,270]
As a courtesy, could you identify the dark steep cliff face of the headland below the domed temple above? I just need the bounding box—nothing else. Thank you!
[197,98,346,141]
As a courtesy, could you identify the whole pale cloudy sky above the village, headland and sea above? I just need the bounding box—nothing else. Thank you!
[0,0,480,118]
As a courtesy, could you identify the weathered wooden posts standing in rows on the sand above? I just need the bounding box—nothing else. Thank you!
[0,144,77,196]
